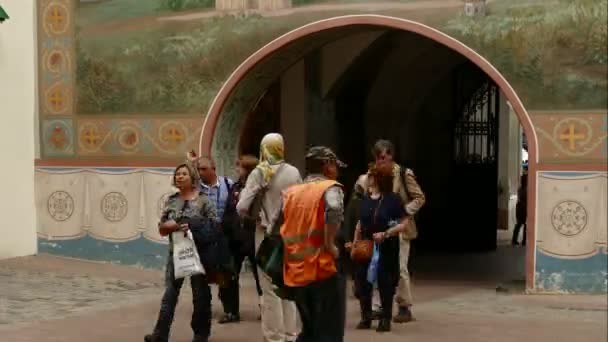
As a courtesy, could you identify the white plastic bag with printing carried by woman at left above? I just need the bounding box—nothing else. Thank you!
[171,231,205,279]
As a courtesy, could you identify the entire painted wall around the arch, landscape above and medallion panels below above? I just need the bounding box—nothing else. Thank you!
[36,0,608,291]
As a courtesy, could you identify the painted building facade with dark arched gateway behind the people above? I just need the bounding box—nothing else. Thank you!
[0,0,608,292]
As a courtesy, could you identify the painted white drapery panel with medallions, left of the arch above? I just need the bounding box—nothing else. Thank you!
[36,168,173,267]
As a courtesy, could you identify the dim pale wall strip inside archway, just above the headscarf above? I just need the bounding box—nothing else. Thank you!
[281,60,308,174]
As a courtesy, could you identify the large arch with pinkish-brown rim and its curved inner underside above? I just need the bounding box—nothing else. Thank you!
[200,15,538,289]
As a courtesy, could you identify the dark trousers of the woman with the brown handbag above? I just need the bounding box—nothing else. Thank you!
[355,263,396,320]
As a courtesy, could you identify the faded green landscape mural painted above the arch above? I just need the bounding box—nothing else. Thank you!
[70,0,608,114]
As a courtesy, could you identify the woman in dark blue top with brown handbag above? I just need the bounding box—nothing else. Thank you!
[351,166,407,332]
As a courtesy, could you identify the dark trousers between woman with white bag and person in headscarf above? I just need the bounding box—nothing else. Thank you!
[218,249,262,315]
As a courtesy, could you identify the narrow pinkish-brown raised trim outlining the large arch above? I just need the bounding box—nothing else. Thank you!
[199,14,538,290]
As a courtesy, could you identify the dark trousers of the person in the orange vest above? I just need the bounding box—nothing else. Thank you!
[291,273,346,342]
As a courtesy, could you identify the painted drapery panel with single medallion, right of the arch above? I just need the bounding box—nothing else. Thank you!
[536,172,608,292]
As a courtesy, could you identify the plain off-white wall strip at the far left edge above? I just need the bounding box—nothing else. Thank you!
[0,0,36,259]
